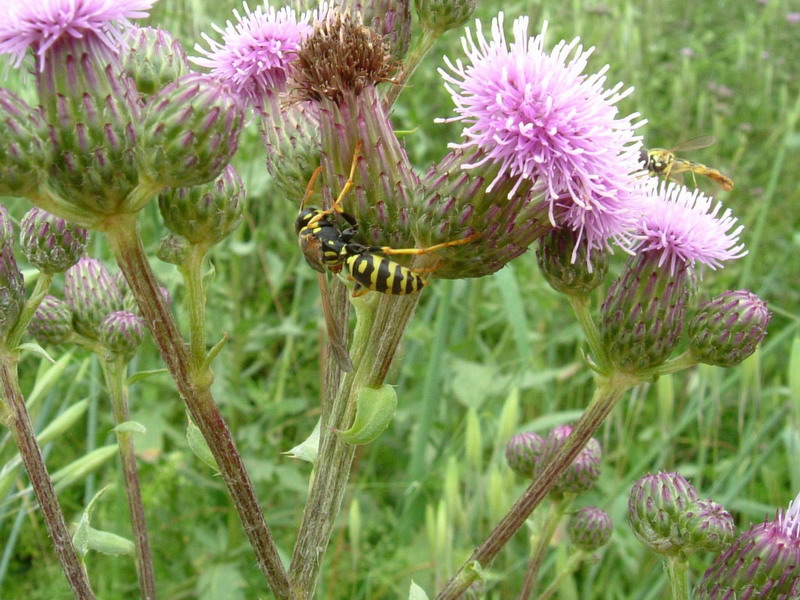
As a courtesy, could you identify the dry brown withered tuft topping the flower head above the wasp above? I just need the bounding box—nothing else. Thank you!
[293,14,394,102]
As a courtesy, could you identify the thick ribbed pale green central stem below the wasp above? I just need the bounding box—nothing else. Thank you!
[289,292,419,600]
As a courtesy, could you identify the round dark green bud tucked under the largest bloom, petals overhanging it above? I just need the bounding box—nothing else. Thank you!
[536,227,608,296]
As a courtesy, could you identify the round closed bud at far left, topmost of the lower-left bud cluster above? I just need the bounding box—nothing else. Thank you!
[19,208,89,274]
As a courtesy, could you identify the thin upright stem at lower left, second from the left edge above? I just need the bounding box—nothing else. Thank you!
[98,352,156,600]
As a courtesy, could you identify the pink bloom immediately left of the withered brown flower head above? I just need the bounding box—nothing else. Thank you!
[189,2,316,106]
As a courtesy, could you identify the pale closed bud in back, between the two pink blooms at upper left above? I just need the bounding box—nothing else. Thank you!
[121,27,190,98]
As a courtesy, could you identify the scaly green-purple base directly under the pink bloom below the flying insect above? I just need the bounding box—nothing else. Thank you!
[600,252,694,373]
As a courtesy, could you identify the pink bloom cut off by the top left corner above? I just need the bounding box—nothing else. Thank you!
[0,0,156,71]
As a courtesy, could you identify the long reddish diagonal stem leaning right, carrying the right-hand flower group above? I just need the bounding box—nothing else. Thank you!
[436,372,639,600]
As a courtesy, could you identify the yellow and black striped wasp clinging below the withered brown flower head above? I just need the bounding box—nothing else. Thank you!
[295,141,480,370]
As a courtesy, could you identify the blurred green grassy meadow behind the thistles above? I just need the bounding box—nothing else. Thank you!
[0,0,800,600]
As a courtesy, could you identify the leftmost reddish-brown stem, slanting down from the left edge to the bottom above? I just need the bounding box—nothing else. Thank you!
[0,347,95,600]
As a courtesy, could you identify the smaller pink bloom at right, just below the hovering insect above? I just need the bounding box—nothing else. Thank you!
[631,182,747,273]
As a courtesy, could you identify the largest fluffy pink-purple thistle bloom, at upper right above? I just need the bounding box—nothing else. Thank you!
[440,13,644,249]
